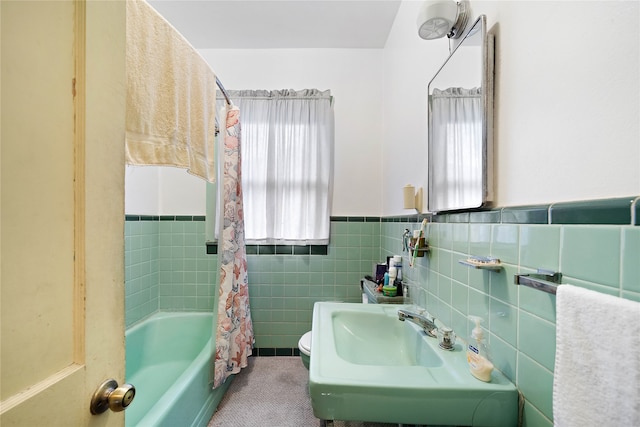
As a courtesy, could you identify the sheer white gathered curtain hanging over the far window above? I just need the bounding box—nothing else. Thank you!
[219,89,334,245]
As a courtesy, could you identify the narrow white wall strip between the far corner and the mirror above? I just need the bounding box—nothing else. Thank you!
[382,1,449,215]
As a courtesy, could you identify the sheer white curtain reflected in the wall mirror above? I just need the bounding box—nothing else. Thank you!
[429,88,483,206]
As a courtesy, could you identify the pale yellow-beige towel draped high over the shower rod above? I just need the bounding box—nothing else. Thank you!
[126,0,216,182]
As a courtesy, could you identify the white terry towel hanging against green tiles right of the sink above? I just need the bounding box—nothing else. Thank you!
[553,285,640,427]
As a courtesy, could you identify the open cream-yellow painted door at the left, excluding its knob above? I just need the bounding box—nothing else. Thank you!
[0,0,125,427]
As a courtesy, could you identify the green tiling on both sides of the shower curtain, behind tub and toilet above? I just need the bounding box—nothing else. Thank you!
[125,219,380,340]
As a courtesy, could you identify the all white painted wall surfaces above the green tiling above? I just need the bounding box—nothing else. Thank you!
[126,0,640,216]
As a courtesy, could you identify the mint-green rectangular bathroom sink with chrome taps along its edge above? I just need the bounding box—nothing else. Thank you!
[309,302,518,427]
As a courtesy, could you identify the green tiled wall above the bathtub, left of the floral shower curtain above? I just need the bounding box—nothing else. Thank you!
[125,215,217,326]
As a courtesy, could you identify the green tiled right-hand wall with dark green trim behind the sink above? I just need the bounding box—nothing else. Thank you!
[381,198,640,427]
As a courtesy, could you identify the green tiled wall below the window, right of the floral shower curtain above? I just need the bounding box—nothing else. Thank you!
[247,218,380,349]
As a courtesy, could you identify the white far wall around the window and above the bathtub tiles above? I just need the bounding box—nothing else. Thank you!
[126,49,384,215]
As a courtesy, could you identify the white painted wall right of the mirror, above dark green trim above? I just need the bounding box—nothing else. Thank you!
[483,1,640,205]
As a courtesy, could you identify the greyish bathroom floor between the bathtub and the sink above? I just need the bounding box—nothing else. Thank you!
[208,357,398,427]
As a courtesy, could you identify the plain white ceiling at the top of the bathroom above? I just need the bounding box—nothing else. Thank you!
[148,0,401,49]
